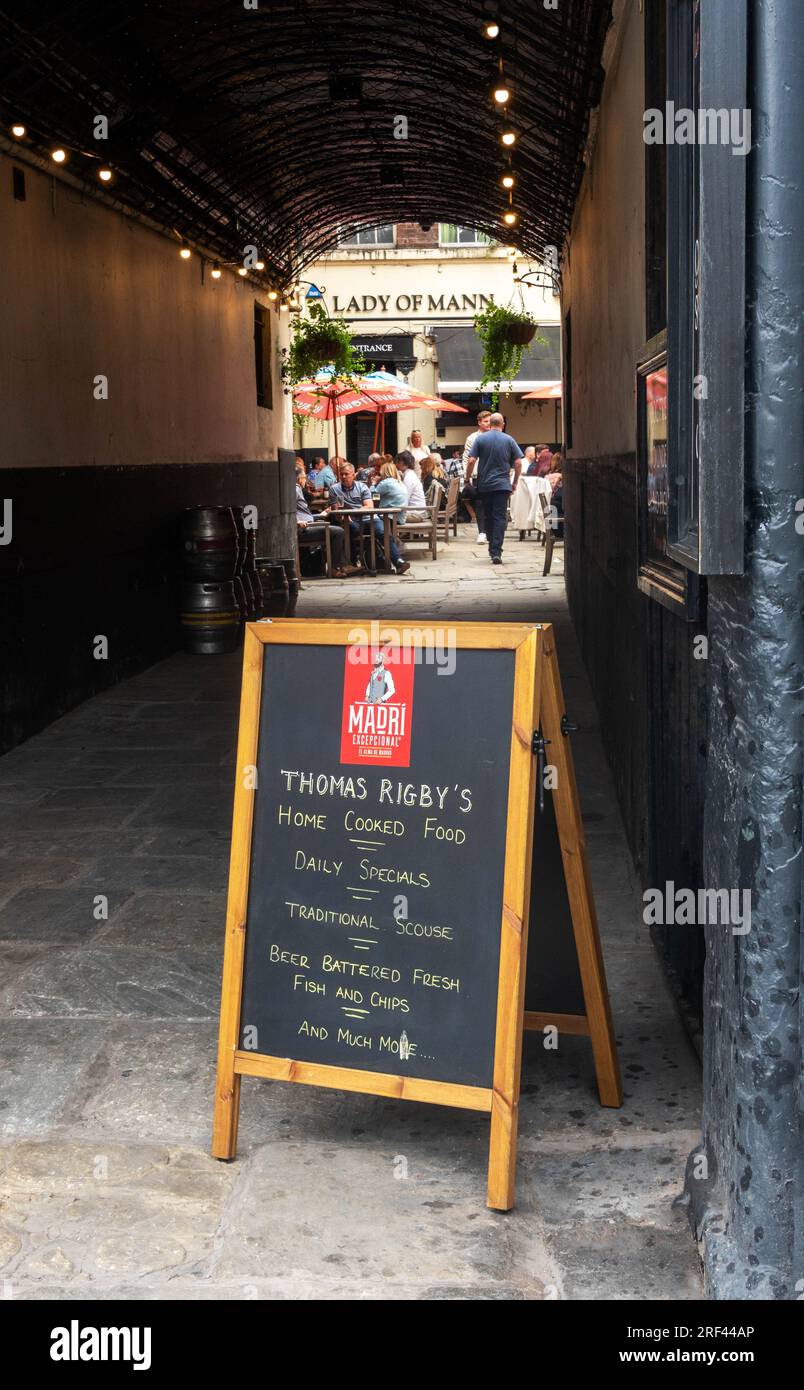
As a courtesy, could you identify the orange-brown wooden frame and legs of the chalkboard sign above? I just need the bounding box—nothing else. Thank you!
[211,619,622,1211]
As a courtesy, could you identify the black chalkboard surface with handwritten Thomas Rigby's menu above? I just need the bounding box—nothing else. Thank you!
[241,644,515,1087]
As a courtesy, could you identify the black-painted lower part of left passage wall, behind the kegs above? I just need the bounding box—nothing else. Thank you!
[0,455,295,752]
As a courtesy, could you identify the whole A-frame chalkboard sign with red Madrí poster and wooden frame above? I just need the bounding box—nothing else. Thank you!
[213,620,620,1211]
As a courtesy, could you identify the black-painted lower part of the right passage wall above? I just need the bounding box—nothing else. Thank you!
[565,453,707,1040]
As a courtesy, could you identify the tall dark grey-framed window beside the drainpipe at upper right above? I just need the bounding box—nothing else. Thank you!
[656,0,748,574]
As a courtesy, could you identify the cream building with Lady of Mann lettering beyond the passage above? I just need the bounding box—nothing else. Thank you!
[296,222,561,466]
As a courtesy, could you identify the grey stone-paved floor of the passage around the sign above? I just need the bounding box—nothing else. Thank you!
[0,535,701,1300]
